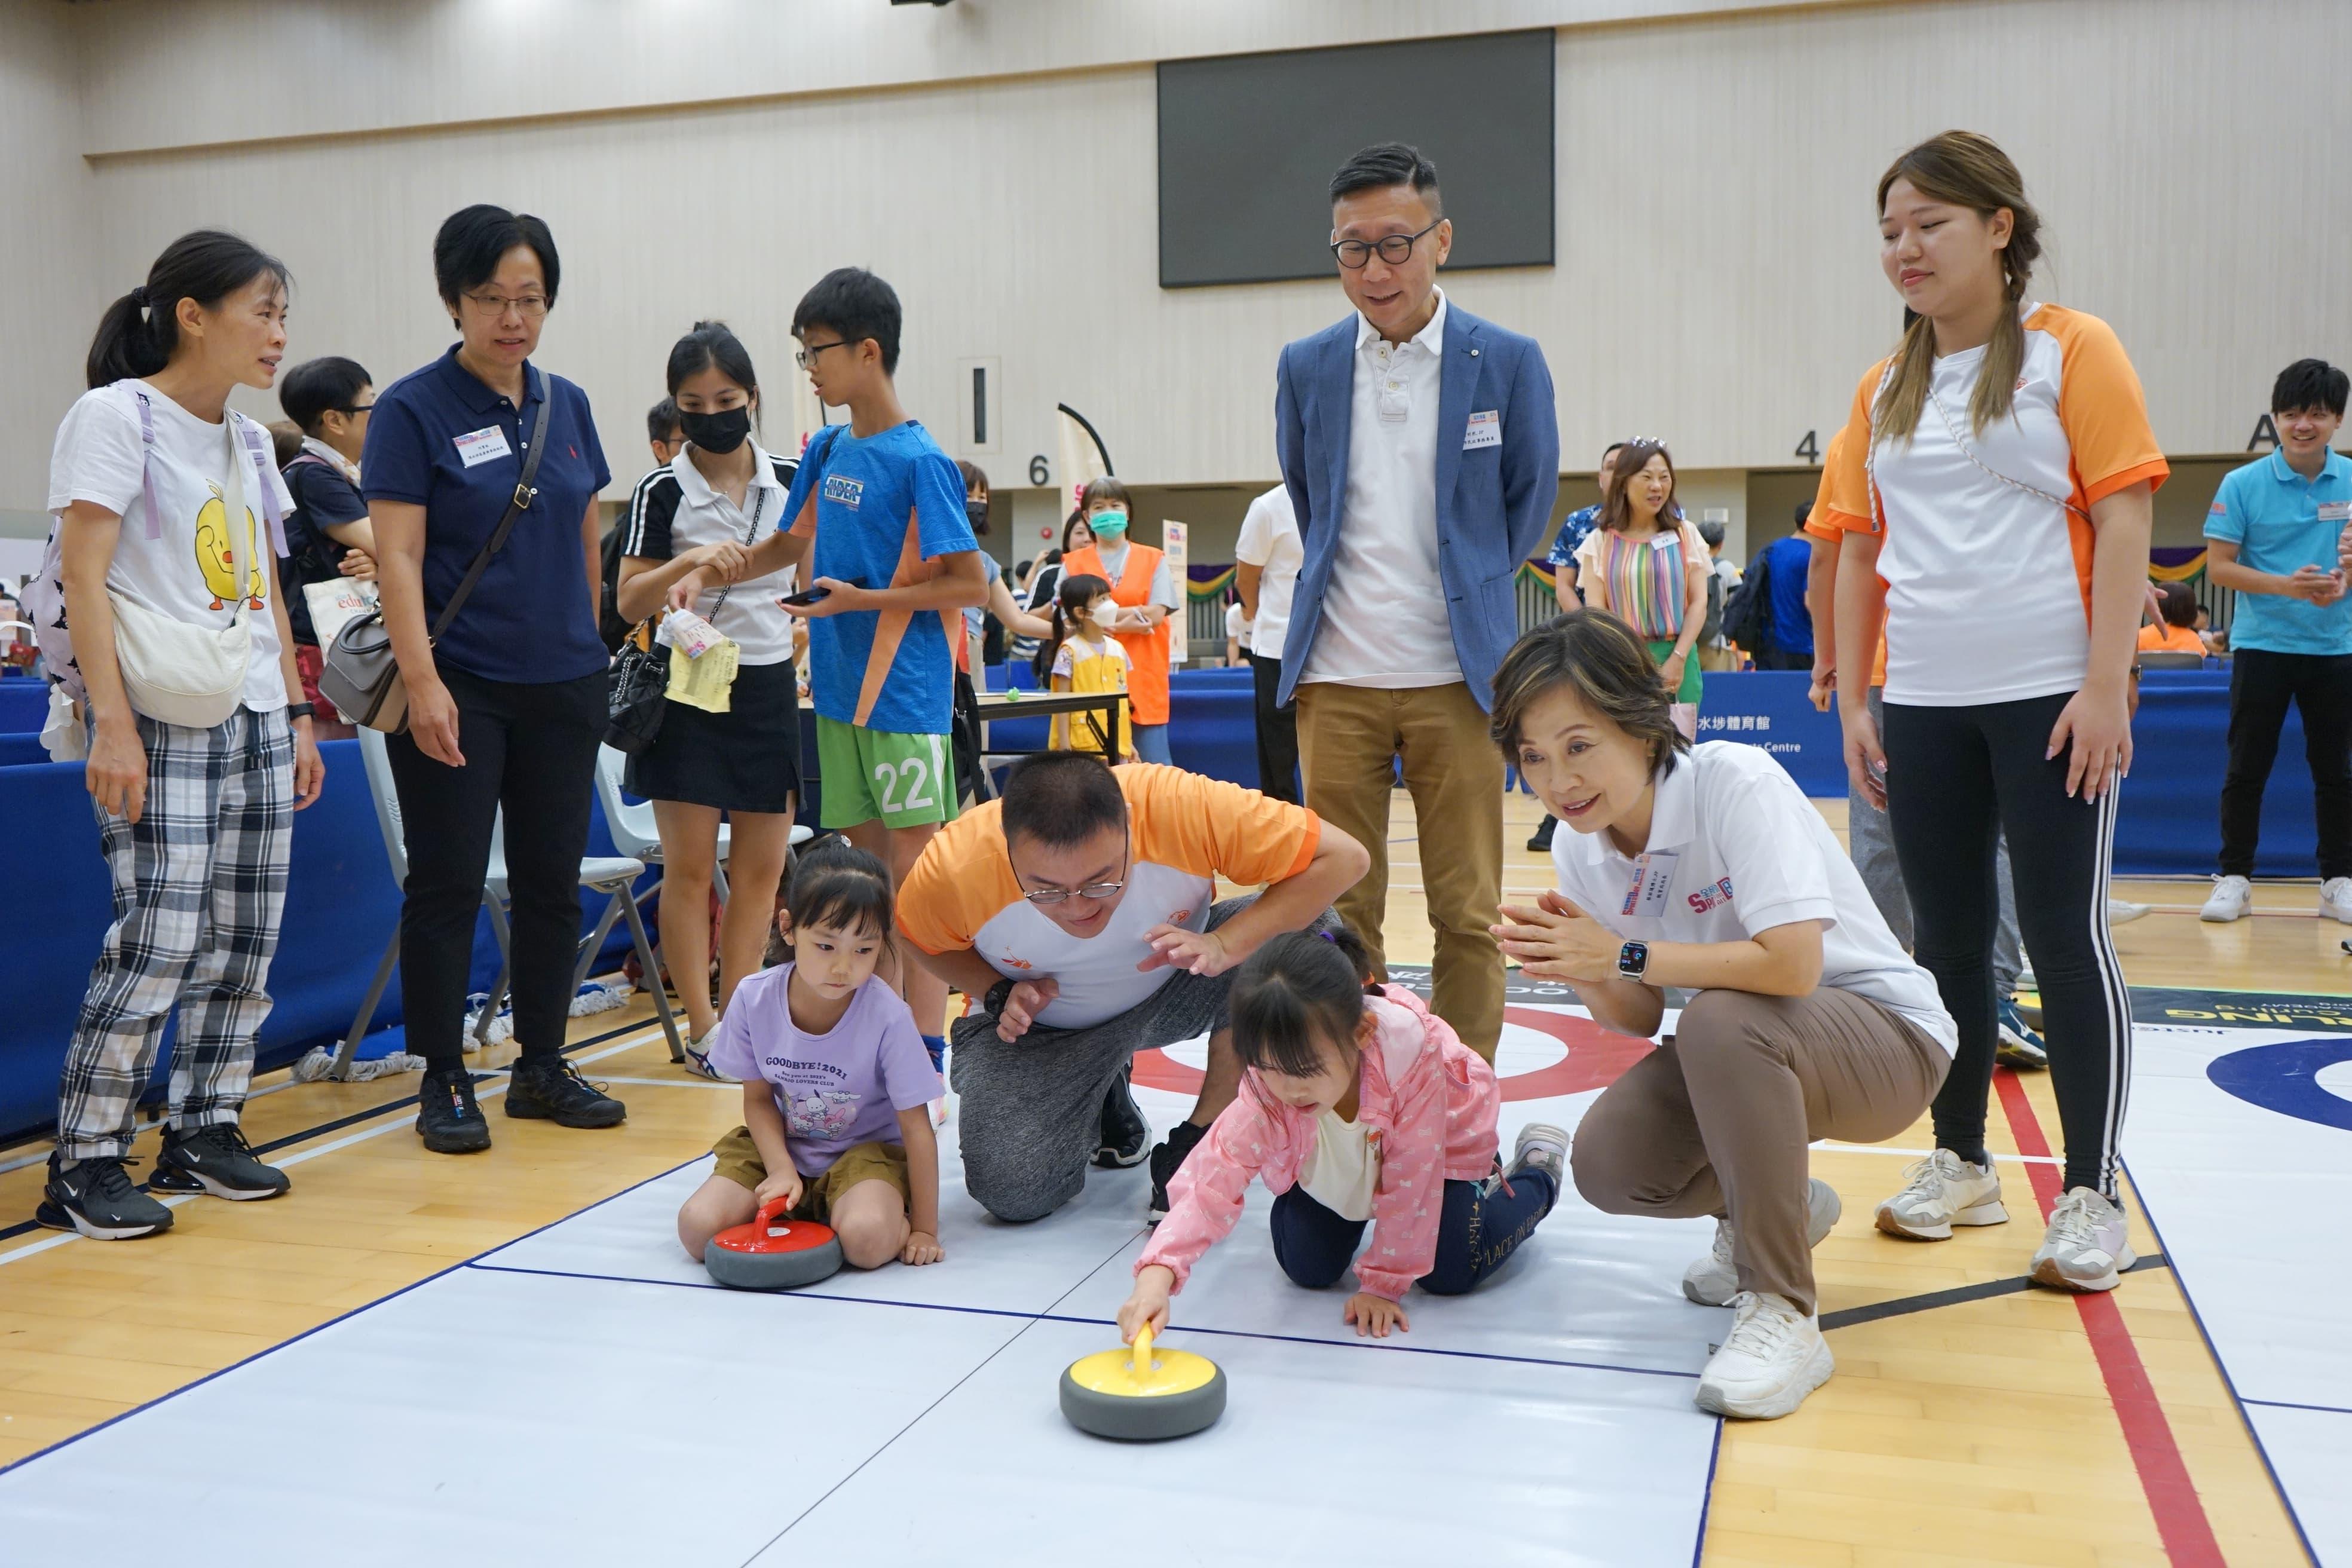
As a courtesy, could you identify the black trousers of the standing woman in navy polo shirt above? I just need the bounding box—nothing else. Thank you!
[386,665,605,1067]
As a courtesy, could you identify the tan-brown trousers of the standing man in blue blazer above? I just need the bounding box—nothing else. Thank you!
[1298,682,1503,1062]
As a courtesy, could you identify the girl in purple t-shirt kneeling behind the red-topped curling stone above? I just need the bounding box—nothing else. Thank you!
[678,846,941,1269]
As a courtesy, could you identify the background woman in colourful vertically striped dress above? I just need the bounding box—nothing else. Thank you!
[1576,440,1714,740]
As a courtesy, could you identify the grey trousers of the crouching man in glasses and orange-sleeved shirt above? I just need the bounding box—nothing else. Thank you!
[948,898,1254,1223]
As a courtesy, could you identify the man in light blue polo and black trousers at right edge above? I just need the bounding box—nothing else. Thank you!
[2201,360,2352,926]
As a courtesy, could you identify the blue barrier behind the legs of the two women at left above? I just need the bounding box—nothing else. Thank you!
[0,740,656,1138]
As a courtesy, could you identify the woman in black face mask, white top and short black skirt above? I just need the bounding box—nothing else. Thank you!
[614,322,800,1072]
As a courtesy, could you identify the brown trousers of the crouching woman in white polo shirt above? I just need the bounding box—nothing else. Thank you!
[1571,987,1952,1312]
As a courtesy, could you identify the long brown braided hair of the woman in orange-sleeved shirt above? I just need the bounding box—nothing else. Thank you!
[1870,131,2041,445]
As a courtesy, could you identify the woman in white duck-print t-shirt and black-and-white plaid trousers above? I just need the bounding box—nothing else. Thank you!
[38,232,324,1241]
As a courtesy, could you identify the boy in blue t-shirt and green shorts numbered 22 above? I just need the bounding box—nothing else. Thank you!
[668,268,988,1065]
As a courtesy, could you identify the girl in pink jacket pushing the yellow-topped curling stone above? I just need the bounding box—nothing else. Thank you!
[1120,931,1569,1340]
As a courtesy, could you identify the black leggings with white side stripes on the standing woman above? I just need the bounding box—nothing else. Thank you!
[1884,694,2131,1199]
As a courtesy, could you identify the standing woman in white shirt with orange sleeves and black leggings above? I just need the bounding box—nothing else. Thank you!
[1830,131,2169,1291]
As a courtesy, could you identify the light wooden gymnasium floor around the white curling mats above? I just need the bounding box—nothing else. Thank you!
[0,795,2347,1568]
